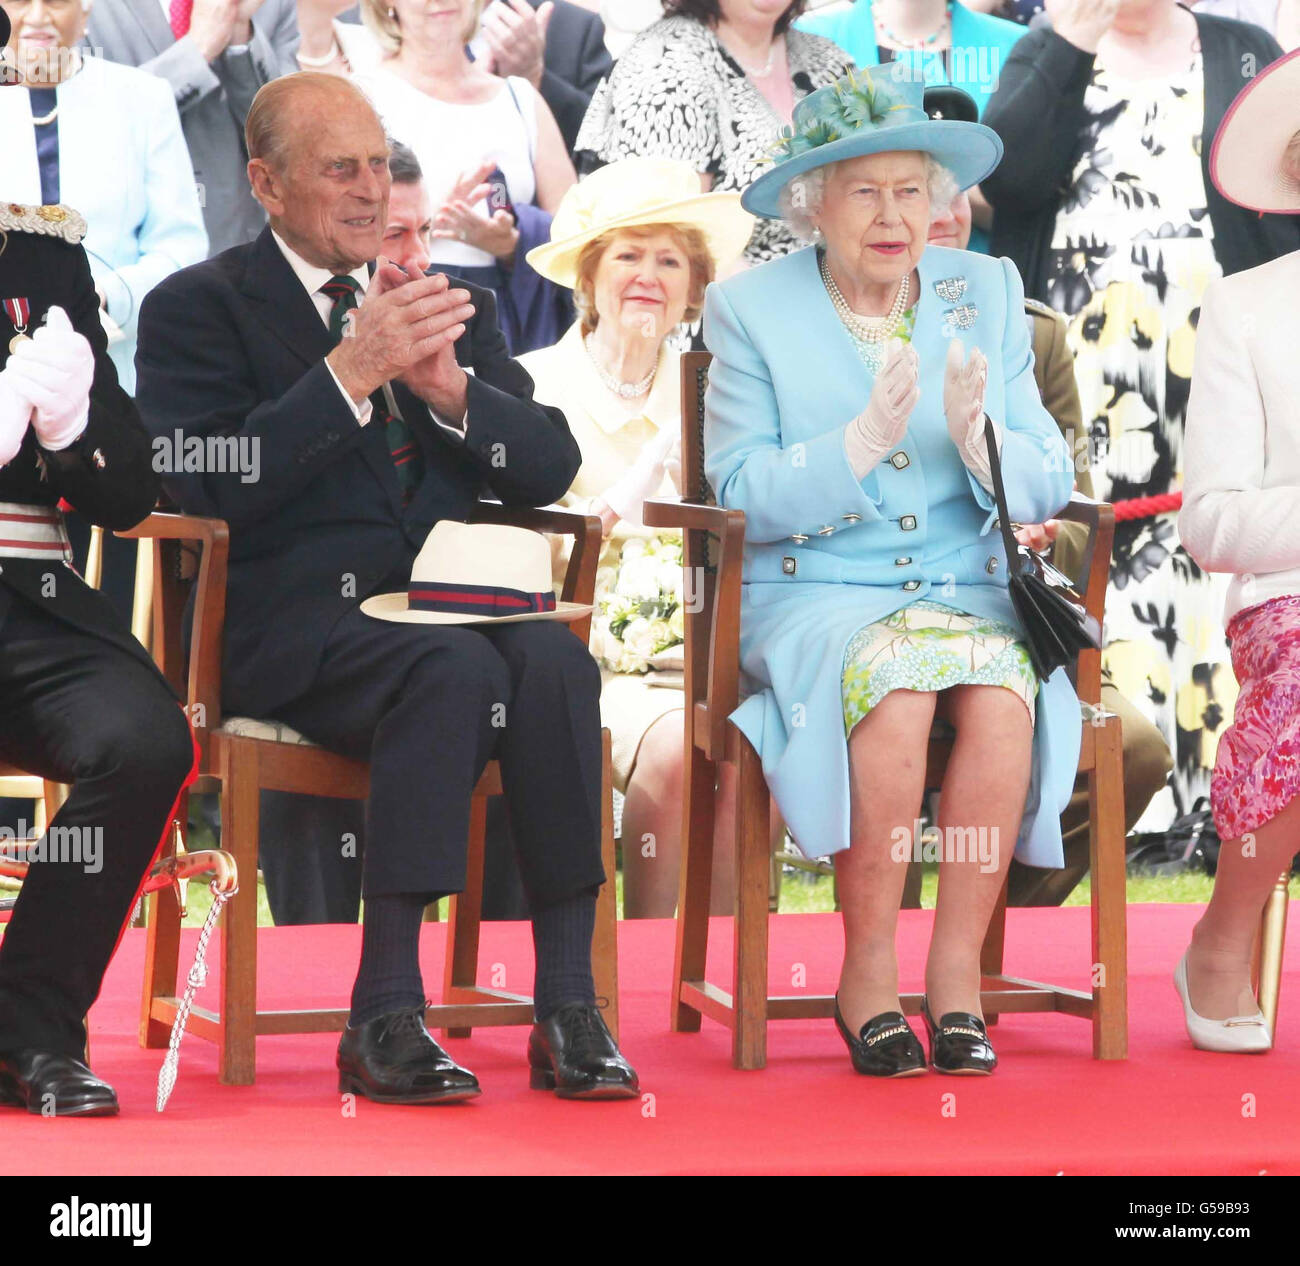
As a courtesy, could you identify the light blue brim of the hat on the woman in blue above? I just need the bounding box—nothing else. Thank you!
[741,118,1002,220]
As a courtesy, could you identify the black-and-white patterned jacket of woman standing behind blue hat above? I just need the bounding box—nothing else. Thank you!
[575,17,853,264]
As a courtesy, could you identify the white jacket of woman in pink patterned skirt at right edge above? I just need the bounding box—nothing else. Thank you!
[1178,251,1300,623]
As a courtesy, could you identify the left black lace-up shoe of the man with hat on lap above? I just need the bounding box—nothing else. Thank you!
[335,1006,482,1104]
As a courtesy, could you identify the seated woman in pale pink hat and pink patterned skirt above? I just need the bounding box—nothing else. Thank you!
[1174,52,1300,1052]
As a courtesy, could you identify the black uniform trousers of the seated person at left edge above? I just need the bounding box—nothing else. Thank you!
[0,594,194,1058]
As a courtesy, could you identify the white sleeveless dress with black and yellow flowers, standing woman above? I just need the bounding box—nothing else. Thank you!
[1048,55,1236,829]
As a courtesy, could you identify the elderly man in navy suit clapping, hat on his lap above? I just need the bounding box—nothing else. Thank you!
[138,73,637,1104]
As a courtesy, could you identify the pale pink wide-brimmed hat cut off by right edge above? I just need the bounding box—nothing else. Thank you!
[1210,48,1300,216]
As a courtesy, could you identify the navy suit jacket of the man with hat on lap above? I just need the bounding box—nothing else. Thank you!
[137,229,581,716]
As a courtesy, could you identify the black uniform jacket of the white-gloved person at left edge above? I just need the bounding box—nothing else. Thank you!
[0,220,159,663]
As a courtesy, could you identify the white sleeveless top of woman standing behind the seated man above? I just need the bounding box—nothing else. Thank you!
[355,68,537,268]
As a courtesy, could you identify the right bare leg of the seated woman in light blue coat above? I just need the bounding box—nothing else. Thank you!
[926,686,1034,1020]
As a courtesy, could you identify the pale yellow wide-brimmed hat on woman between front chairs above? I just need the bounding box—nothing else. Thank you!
[527,159,754,290]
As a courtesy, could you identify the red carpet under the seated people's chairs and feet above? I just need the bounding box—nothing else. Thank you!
[12,906,1300,1175]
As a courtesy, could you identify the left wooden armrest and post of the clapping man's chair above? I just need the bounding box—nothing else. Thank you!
[116,512,230,769]
